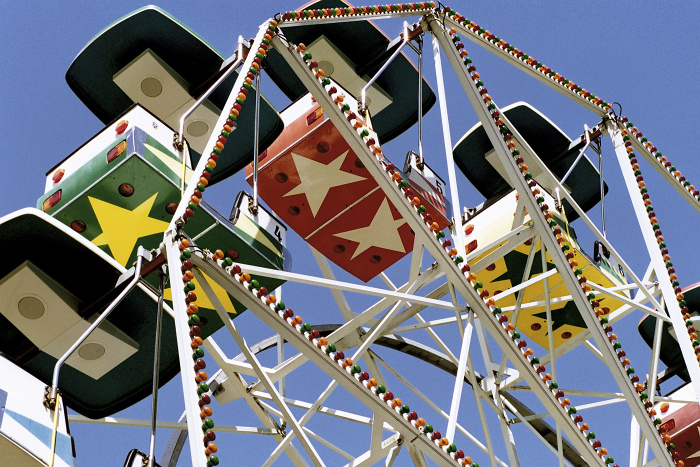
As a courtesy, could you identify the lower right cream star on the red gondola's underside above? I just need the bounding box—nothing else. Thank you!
[334,198,406,259]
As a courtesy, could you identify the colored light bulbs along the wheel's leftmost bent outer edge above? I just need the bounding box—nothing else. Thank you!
[178,20,277,467]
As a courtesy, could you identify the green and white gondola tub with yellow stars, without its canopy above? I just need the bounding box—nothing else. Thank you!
[37,105,289,335]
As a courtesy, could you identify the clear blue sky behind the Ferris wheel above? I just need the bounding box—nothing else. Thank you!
[0,0,700,466]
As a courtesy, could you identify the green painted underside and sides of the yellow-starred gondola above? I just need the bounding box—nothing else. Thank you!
[39,146,284,337]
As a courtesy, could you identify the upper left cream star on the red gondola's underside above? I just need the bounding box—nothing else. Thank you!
[284,151,365,217]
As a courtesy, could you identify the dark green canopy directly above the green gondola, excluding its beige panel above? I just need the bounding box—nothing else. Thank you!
[66,6,284,182]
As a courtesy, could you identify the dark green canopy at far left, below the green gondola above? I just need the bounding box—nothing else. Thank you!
[0,208,180,418]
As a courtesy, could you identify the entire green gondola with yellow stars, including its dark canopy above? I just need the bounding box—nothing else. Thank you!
[37,6,288,333]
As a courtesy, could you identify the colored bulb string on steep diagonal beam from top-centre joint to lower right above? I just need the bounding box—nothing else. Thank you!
[442,19,688,465]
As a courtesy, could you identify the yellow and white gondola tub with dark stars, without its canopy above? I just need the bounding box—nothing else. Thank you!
[462,185,629,348]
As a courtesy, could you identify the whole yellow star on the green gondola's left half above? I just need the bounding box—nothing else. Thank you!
[88,193,168,266]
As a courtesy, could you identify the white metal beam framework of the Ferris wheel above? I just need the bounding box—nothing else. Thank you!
[144,4,700,465]
